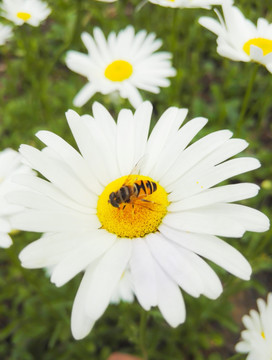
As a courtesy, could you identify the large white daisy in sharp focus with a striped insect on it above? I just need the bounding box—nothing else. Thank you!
[9,102,269,339]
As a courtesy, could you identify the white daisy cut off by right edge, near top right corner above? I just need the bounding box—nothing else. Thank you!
[199,2,272,72]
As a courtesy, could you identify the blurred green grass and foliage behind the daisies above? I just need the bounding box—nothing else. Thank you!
[0,0,272,360]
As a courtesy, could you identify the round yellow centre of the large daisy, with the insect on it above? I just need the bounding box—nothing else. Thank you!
[97,175,169,239]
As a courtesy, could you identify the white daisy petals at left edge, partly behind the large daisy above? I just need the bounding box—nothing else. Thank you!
[0,149,32,248]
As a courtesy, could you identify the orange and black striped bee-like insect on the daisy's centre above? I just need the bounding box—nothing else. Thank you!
[108,175,157,209]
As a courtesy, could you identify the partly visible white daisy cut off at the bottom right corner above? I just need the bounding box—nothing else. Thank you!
[235,293,272,360]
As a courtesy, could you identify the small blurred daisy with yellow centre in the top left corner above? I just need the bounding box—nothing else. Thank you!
[0,0,51,26]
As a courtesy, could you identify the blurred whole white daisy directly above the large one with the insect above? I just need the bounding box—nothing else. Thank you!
[66,26,176,107]
